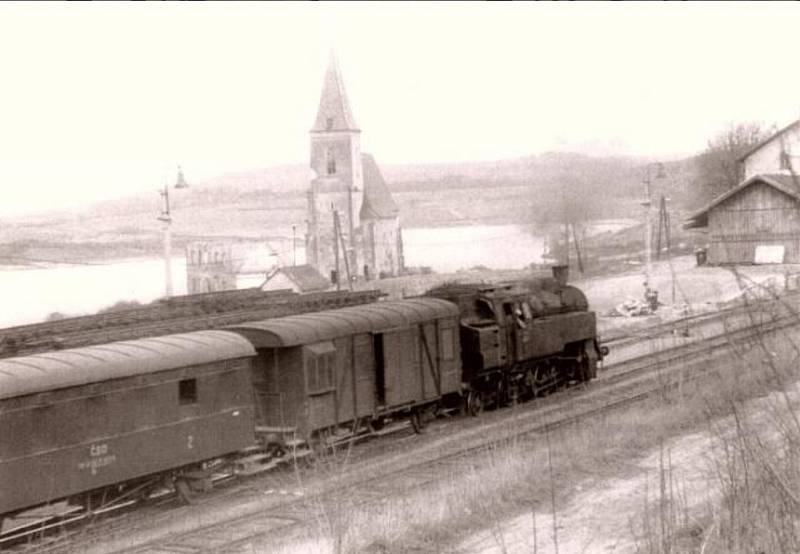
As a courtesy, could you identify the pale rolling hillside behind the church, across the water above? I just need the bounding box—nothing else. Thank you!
[0,152,695,264]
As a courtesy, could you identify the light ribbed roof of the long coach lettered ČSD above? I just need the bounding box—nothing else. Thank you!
[0,331,255,399]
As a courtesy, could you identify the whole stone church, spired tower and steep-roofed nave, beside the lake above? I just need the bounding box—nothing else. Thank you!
[306,54,403,286]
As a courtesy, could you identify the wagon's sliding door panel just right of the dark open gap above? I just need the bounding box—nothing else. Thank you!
[375,329,422,407]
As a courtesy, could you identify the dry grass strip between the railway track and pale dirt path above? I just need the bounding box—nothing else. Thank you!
[262,382,720,552]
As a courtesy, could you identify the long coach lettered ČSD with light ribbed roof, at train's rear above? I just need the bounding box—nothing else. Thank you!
[0,331,255,525]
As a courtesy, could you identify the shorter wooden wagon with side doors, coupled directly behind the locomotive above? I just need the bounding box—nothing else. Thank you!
[229,298,461,445]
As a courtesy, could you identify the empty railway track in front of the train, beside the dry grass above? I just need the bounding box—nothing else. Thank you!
[15,296,797,554]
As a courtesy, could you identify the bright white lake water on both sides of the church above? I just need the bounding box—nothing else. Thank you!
[0,222,626,327]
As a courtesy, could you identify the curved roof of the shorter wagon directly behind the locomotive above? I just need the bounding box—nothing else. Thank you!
[228,298,458,348]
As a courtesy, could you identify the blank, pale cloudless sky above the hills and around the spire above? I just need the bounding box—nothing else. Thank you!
[0,2,800,216]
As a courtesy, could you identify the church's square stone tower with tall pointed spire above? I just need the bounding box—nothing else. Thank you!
[306,53,364,286]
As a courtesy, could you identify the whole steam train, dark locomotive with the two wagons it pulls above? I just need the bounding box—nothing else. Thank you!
[0,268,607,529]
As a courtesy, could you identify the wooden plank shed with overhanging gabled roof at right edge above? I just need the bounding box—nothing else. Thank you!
[684,174,800,265]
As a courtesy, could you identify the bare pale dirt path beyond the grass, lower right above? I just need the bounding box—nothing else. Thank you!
[453,384,800,554]
